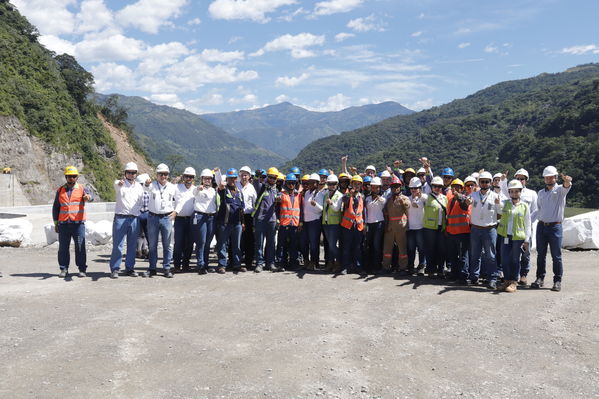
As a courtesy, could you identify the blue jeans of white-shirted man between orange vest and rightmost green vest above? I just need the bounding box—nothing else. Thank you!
[468,226,499,280]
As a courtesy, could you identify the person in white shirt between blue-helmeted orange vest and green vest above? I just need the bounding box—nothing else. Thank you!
[301,173,325,270]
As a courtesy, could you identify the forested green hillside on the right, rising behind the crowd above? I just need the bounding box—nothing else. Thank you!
[287,64,599,208]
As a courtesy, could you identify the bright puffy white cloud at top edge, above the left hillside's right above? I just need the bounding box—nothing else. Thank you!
[116,0,187,34]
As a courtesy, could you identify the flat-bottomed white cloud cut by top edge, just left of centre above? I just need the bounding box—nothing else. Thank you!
[208,0,297,23]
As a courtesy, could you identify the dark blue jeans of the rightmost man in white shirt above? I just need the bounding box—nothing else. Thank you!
[537,222,564,282]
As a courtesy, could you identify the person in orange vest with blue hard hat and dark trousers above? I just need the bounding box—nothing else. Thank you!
[272,173,302,272]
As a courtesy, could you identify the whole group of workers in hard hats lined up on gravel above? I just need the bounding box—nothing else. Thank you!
[53,157,572,292]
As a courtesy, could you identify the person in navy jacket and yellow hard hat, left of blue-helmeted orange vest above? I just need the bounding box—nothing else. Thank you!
[252,167,279,273]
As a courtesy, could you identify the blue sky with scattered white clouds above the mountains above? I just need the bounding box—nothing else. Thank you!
[12,0,599,113]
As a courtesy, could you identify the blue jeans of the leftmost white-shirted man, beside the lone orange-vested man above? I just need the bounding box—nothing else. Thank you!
[110,215,139,272]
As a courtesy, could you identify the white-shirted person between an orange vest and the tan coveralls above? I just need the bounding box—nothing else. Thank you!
[364,176,387,273]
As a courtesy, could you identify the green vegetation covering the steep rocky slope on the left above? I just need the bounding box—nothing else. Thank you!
[0,0,120,199]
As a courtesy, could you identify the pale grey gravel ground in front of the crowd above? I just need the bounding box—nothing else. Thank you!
[0,247,599,399]
